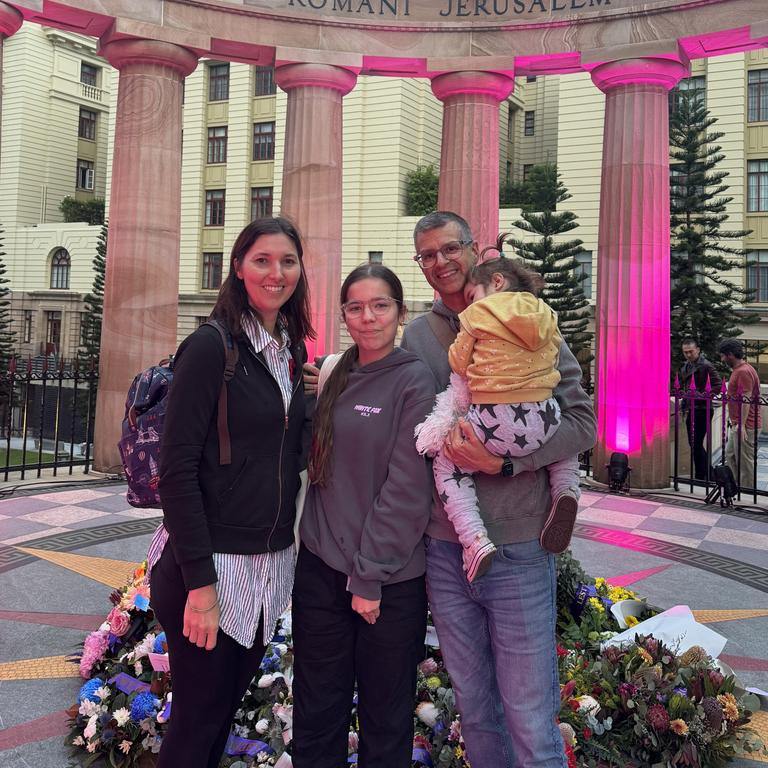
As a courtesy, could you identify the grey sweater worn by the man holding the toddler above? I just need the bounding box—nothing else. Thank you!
[402,300,597,546]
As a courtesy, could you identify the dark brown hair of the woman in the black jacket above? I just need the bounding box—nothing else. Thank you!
[211,216,316,345]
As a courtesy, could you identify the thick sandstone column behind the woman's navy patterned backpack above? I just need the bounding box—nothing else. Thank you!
[94,39,196,471]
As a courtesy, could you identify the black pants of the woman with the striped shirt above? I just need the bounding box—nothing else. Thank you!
[152,544,264,768]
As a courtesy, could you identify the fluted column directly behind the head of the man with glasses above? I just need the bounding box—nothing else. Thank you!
[432,72,515,249]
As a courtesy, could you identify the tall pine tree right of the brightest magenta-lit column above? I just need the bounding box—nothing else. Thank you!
[669,90,758,371]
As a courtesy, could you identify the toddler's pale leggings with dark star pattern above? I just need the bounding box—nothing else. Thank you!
[433,397,580,547]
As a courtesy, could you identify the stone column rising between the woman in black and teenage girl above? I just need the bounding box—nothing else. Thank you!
[275,64,357,361]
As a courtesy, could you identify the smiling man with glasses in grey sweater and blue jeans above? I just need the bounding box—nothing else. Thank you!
[402,211,596,768]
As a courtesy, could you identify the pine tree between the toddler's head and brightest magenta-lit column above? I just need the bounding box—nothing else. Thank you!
[507,164,592,374]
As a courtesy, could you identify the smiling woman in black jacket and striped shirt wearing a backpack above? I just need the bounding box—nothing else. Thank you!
[149,218,314,768]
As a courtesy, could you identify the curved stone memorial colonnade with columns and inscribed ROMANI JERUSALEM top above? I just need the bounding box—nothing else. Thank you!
[0,0,768,487]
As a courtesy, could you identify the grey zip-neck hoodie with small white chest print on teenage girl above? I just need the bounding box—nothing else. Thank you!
[301,349,435,600]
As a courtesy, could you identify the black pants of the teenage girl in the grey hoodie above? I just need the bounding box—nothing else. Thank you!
[292,547,427,768]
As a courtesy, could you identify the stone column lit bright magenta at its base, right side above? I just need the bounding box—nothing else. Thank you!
[592,58,688,488]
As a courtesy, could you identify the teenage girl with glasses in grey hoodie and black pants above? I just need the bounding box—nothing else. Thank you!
[292,264,435,768]
